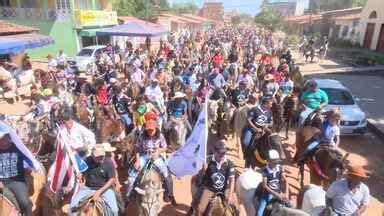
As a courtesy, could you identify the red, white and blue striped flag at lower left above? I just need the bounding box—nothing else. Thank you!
[50,127,88,193]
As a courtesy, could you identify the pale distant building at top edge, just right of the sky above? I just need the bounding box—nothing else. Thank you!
[268,0,305,16]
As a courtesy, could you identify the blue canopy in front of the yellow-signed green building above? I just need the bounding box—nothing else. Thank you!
[96,20,168,37]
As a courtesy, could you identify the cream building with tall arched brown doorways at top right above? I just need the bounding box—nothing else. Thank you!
[359,0,384,53]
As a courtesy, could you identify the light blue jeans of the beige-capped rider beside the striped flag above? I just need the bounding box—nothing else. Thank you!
[70,186,119,216]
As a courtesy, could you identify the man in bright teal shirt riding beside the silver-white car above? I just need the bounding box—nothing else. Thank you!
[299,80,328,125]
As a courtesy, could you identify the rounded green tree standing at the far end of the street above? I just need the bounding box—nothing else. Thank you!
[255,5,282,27]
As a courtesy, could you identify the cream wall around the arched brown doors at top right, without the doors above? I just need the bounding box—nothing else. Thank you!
[359,0,384,50]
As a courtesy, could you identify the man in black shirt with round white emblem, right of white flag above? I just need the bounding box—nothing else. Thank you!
[187,140,235,215]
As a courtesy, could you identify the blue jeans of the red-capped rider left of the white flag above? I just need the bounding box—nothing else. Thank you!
[127,154,168,197]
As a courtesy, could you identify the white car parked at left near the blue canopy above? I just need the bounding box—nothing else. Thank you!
[68,45,106,71]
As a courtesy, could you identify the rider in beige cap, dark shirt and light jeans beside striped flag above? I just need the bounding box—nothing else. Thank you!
[70,146,119,216]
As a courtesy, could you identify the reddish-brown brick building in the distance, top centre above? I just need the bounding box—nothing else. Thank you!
[198,1,224,25]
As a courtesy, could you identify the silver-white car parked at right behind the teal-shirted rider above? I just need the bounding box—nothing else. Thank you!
[315,79,367,135]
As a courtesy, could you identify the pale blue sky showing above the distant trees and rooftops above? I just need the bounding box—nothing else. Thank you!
[168,0,308,15]
